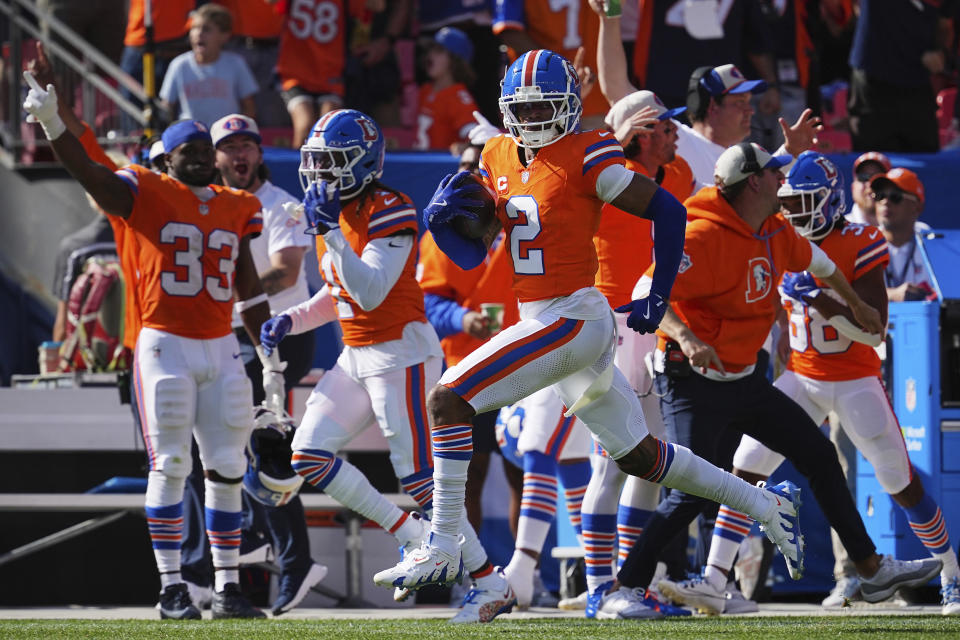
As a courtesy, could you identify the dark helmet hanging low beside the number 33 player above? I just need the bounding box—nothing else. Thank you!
[243,406,303,507]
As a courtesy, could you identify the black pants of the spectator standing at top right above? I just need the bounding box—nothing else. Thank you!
[850,69,940,153]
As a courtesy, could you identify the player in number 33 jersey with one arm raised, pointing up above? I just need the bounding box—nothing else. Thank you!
[24,72,282,619]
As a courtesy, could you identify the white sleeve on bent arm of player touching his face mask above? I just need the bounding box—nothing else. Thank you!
[323,229,416,311]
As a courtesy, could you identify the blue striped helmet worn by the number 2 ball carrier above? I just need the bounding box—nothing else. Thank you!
[500,49,583,149]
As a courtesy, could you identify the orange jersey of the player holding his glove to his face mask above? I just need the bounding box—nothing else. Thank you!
[317,190,427,347]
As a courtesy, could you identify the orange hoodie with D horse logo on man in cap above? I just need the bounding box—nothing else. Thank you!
[660,187,813,373]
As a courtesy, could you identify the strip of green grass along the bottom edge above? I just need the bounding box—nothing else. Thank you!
[0,616,960,640]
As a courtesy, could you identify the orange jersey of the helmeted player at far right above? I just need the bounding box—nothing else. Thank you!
[781,224,890,380]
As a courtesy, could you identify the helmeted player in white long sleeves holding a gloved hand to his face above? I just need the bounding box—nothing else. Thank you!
[255,109,515,622]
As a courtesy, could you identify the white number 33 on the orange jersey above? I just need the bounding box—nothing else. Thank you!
[160,222,240,302]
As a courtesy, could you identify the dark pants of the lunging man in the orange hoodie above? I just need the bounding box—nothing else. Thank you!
[617,358,876,587]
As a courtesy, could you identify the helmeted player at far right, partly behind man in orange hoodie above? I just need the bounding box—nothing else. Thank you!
[675,151,960,615]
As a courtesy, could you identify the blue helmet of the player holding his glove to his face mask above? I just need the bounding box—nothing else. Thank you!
[300,109,386,199]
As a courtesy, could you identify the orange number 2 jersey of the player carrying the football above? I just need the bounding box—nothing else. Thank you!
[480,130,624,302]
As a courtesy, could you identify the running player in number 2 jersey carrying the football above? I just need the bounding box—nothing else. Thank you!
[374,50,816,608]
